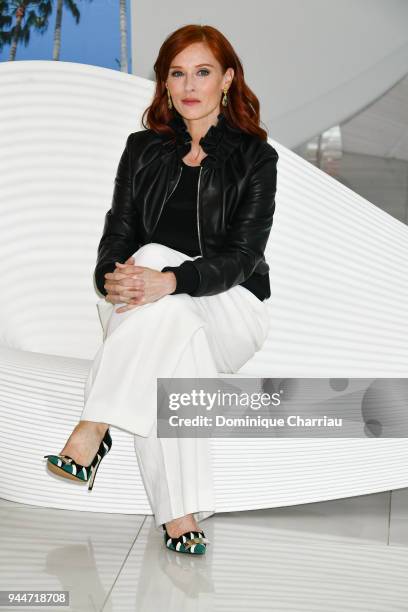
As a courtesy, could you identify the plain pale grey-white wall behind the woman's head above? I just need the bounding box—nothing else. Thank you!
[131,0,408,148]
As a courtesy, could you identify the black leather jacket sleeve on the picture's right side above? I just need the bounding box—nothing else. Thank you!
[161,144,279,297]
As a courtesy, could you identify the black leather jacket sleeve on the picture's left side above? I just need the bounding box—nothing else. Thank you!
[94,134,138,295]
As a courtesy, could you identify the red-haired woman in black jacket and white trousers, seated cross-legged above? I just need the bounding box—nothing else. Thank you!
[46,25,278,553]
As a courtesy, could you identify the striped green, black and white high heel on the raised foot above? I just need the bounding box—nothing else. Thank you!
[44,428,112,491]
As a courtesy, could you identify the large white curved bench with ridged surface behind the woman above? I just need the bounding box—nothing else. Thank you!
[0,61,408,514]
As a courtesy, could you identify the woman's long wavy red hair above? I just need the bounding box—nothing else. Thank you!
[142,24,268,140]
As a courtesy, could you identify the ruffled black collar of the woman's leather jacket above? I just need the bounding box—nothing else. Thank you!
[163,111,242,167]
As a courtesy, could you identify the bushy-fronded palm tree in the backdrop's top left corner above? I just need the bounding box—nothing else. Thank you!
[5,0,52,62]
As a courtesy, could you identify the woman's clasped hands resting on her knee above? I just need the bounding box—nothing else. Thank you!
[104,256,177,312]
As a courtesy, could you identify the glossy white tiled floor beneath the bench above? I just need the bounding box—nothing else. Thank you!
[0,489,408,612]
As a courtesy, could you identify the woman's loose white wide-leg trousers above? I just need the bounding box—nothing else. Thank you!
[81,243,269,529]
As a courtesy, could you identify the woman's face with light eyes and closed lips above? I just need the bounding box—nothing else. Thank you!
[167,43,234,120]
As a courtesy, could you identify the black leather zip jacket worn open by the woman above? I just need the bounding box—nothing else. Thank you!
[94,112,278,297]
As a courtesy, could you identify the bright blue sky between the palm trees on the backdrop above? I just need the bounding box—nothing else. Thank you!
[0,0,132,72]
